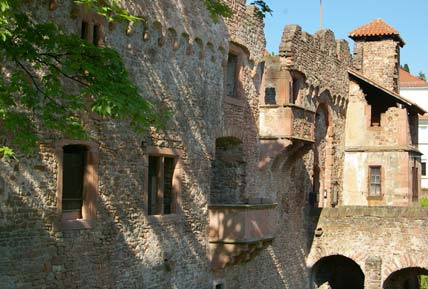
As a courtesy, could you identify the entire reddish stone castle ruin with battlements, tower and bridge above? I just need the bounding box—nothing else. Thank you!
[0,0,428,289]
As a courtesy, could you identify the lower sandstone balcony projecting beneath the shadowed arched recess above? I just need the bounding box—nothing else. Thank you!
[208,204,276,270]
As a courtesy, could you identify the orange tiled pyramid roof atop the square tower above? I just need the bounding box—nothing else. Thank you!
[349,18,406,46]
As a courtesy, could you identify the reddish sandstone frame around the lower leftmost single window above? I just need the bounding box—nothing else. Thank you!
[55,140,99,230]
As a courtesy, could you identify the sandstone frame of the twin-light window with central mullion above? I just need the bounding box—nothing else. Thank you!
[143,146,183,218]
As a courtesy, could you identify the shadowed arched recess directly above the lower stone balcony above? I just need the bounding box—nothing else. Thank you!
[210,136,246,204]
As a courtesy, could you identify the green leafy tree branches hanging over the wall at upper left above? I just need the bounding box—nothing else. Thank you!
[0,0,167,155]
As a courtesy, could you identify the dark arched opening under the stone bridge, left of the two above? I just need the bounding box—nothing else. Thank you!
[311,255,365,289]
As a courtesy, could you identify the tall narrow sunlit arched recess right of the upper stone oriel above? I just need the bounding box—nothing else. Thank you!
[310,102,333,207]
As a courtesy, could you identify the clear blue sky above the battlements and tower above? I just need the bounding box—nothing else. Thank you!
[265,0,428,76]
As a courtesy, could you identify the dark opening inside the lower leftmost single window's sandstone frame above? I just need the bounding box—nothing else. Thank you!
[62,145,87,219]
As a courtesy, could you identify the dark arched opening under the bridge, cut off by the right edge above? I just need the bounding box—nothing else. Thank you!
[382,267,428,289]
